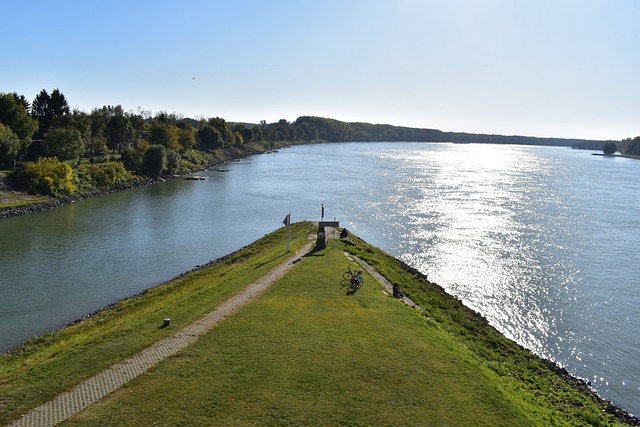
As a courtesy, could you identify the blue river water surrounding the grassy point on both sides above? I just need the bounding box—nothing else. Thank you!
[0,143,640,413]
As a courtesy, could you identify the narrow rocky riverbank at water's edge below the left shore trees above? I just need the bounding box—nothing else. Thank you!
[0,141,291,219]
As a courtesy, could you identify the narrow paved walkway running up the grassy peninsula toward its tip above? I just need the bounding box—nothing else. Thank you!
[9,242,313,427]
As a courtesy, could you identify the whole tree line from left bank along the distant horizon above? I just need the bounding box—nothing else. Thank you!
[0,89,640,193]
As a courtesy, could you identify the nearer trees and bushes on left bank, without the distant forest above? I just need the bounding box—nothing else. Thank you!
[0,89,308,195]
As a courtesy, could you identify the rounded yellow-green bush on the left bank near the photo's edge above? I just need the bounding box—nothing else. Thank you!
[17,157,75,196]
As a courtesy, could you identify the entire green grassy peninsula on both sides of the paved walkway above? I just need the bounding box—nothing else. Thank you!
[0,222,633,426]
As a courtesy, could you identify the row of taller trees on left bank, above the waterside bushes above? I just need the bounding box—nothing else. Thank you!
[0,89,316,172]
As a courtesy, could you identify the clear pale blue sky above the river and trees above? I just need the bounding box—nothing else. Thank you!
[0,0,640,139]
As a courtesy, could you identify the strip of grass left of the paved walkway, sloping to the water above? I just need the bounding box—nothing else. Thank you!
[0,223,318,423]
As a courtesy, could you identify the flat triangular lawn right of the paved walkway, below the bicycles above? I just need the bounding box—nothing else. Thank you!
[68,244,535,426]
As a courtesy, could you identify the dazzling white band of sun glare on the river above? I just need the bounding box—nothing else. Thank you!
[376,146,555,352]
